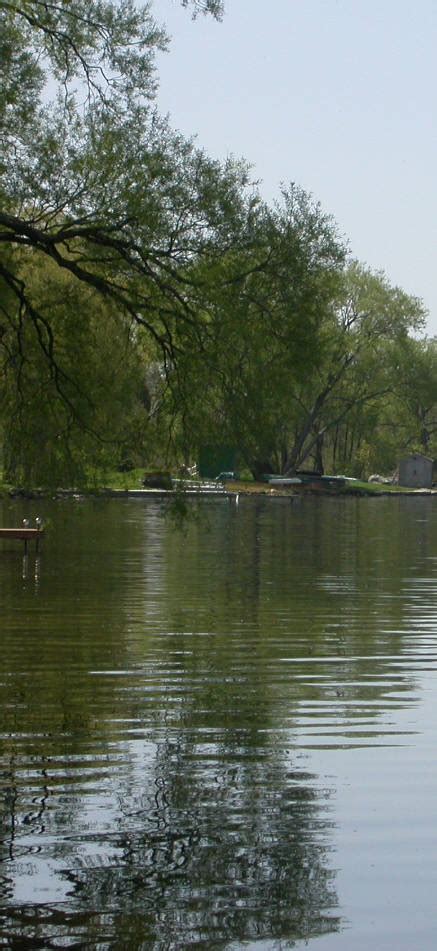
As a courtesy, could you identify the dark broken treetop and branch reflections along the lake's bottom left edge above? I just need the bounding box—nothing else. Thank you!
[0,729,340,949]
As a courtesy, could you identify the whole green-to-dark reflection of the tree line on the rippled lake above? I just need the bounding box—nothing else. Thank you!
[0,494,426,951]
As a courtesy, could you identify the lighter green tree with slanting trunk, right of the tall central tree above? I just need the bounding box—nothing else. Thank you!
[285,262,425,472]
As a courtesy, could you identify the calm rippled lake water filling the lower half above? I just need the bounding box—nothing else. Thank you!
[0,497,437,951]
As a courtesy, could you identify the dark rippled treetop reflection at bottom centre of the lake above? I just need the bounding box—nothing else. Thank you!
[62,740,339,948]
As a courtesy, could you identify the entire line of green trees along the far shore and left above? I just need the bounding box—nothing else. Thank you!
[0,0,437,483]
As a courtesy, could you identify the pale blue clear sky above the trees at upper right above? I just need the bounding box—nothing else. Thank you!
[154,0,437,336]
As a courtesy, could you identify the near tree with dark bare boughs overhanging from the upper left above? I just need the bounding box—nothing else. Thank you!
[0,0,252,476]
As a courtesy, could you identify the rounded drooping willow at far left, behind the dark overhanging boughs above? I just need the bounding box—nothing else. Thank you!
[0,256,151,485]
